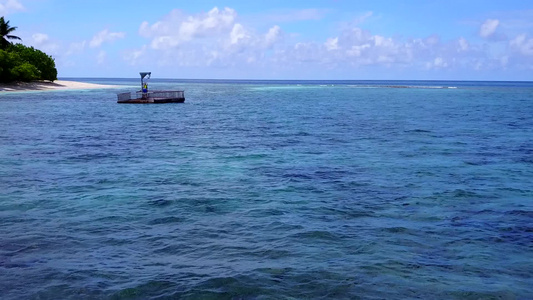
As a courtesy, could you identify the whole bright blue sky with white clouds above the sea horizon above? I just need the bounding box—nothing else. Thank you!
[0,0,533,81]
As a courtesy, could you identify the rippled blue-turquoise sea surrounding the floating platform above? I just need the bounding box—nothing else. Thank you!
[0,79,533,299]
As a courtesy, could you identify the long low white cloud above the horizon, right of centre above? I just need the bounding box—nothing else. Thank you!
[273,27,500,71]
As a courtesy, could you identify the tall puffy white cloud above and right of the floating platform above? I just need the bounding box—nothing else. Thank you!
[131,7,284,67]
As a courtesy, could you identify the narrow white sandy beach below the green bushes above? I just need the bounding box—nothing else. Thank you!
[0,80,121,93]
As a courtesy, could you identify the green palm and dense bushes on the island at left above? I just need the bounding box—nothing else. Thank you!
[0,17,57,82]
